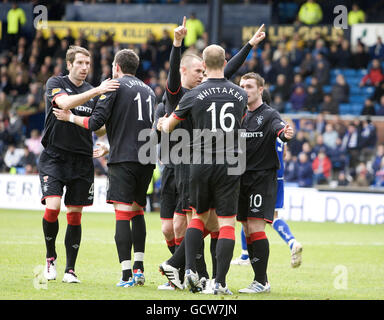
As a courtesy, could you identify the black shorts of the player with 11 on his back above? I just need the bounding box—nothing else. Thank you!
[107,162,155,208]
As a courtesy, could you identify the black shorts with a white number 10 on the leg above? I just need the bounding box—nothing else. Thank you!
[237,169,277,223]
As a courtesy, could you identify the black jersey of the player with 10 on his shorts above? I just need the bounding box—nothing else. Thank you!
[241,103,285,171]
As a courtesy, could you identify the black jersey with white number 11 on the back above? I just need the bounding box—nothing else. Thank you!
[88,75,156,163]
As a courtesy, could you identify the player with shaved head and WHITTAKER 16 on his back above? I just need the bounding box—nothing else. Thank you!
[158,45,247,294]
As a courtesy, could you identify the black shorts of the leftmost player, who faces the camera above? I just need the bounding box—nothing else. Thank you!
[38,148,95,206]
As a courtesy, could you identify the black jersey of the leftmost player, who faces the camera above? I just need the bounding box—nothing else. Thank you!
[42,76,97,157]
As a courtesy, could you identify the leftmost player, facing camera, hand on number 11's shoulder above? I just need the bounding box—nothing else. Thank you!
[38,46,119,283]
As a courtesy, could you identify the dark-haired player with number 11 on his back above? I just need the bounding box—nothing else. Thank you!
[54,49,155,287]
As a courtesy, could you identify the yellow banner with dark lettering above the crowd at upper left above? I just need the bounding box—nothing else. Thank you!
[41,21,177,44]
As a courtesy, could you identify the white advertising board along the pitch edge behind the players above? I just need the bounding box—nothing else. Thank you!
[0,174,384,224]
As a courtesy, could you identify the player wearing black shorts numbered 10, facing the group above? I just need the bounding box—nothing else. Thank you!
[237,73,294,293]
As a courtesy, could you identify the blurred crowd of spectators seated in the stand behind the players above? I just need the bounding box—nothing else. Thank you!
[0,1,384,187]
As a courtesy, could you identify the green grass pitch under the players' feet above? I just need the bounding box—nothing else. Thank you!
[0,209,384,300]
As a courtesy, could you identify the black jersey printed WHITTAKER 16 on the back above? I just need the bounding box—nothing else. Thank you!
[173,78,248,161]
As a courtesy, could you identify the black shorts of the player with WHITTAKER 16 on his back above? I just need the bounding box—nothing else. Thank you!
[189,164,240,217]
